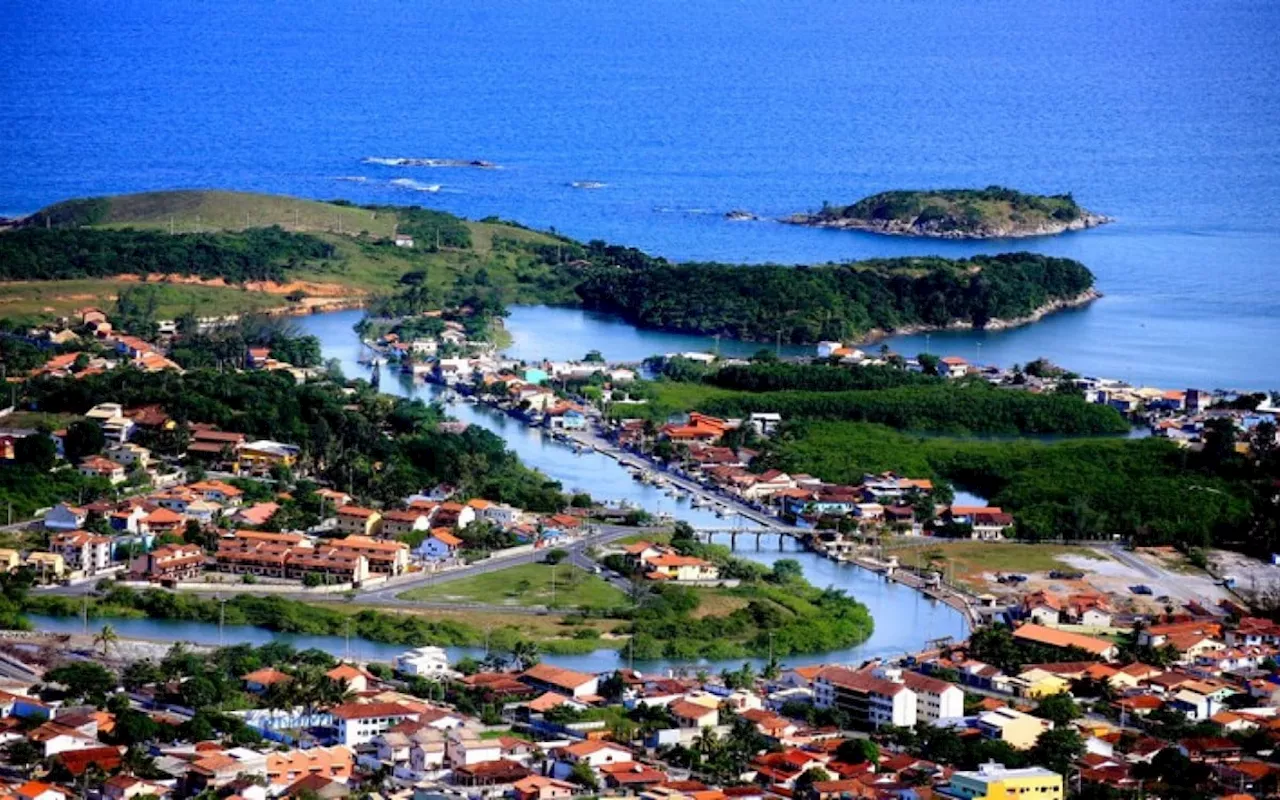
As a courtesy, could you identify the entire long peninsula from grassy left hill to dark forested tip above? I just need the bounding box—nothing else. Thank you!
[0,191,1096,344]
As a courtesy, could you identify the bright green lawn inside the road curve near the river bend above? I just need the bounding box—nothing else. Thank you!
[399,563,627,608]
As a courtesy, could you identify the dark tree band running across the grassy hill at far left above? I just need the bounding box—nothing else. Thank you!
[0,227,337,283]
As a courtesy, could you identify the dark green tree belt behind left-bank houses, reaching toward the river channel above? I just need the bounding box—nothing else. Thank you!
[17,367,563,511]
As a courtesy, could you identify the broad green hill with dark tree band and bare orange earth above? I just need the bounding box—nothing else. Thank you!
[0,189,576,320]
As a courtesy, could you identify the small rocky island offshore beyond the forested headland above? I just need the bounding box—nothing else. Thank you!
[782,186,1111,239]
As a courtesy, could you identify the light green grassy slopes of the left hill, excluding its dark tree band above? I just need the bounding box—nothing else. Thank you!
[0,191,575,323]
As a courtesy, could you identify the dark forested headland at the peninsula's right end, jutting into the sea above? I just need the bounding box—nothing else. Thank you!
[577,250,1093,343]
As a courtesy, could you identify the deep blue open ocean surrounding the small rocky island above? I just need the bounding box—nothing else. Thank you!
[0,0,1280,387]
